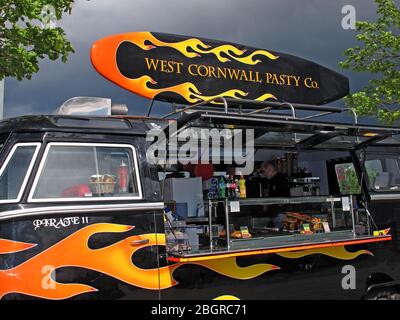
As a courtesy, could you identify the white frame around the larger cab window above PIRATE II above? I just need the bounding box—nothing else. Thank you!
[28,142,143,202]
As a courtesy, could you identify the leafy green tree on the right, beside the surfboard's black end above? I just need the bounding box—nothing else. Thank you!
[340,0,400,124]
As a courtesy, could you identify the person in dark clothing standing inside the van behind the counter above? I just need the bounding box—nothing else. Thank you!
[261,161,290,229]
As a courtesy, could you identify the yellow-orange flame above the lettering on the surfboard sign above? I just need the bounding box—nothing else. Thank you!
[122,32,279,65]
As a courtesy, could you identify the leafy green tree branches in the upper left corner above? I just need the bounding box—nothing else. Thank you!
[0,0,74,80]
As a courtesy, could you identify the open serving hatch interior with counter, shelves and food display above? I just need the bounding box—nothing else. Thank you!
[160,148,384,259]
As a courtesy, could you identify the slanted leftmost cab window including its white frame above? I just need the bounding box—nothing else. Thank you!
[0,143,39,202]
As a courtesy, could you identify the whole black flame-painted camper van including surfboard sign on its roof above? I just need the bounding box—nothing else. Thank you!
[0,32,400,300]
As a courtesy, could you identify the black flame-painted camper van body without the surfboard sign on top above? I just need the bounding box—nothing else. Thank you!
[0,95,400,299]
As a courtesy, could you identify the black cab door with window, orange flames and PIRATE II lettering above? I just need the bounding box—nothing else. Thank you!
[0,142,163,300]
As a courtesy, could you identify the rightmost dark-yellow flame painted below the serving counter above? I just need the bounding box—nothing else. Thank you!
[276,246,373,260]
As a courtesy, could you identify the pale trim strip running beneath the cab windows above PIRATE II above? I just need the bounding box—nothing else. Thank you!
[0,202,164,221]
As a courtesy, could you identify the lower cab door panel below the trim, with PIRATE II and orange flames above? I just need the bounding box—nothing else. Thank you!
[0,209,159,300]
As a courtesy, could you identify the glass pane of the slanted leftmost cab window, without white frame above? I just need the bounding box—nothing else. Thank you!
[0,145,37,200]
